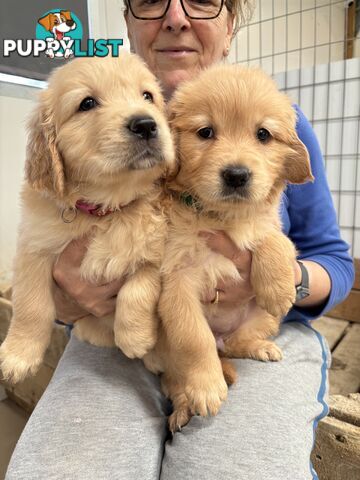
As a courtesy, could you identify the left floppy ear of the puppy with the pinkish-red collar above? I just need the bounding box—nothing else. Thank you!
[25,94,65,196]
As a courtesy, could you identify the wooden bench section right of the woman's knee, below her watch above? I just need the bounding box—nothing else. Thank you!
[312,259,360,480]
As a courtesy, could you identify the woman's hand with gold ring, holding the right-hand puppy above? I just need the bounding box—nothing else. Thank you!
[199,231,255,308]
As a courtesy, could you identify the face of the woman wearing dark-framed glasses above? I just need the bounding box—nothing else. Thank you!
[125,0,233,97]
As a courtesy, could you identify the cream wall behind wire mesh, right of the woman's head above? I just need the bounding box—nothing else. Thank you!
[231,0,345,74]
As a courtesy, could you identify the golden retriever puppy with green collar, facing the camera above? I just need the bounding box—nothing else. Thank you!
[144,66,313,431]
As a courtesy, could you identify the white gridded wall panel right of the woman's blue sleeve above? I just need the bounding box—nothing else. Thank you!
[275,58,360,258]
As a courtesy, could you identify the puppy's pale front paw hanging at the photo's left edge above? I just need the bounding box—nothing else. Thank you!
[0,340,42,383]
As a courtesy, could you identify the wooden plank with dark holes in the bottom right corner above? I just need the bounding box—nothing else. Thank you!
[311,417,360,480]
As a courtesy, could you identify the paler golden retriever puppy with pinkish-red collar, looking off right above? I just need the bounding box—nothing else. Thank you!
[0,54,174,382]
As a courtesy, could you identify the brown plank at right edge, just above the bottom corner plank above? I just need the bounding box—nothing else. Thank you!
[330,324,360,395]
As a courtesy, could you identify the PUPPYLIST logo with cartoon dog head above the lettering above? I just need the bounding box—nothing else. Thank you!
[3,9,123,59]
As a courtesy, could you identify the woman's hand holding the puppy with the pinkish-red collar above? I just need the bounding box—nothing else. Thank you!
[53,238,124,323]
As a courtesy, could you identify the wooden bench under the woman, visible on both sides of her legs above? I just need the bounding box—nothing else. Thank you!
[0,261,360,480]
